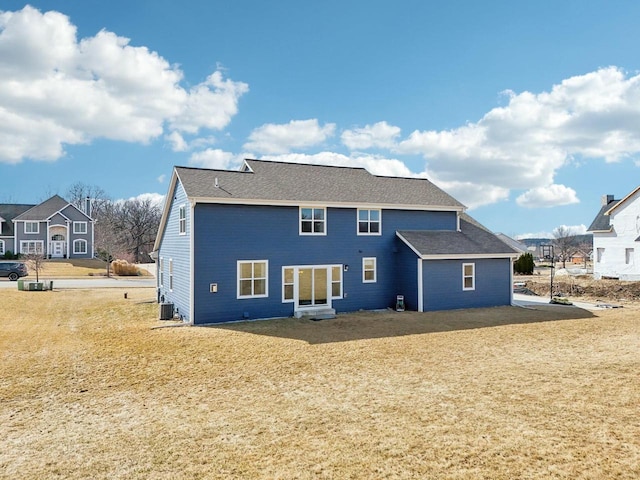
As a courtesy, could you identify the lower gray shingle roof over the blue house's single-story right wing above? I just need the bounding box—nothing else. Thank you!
[398,215,518,256]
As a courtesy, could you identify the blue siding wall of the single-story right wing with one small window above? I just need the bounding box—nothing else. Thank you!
[422,258,511,311]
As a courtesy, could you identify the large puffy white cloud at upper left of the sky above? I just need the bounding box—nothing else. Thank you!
[0,6,248,163]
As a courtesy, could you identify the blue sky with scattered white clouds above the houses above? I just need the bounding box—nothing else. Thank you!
[0,0,640,237]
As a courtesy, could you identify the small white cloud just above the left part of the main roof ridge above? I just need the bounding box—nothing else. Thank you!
[244,118,336,154]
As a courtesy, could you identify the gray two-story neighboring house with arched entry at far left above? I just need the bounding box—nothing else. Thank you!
[0,195,94,258]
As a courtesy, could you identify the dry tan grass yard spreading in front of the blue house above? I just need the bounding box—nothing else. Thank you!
[0,289,640,480]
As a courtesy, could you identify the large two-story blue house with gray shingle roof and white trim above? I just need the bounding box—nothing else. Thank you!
[154,160,517,324]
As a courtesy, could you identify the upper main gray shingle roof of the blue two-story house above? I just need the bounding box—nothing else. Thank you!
[176,160,464,210]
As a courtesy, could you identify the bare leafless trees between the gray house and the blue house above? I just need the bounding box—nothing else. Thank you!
[67,182,162,263]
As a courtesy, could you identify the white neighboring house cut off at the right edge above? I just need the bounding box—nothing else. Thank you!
[588,187,640,280]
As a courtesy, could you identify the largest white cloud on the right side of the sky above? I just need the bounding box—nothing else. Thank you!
[392,67,640,205]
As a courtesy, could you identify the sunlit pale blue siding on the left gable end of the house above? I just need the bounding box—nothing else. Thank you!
[158,183,191,321]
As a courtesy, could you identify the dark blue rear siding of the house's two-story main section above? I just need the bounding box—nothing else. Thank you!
[191,204,456,323]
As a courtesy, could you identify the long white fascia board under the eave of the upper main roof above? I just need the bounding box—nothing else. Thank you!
[189,197,464,212]
